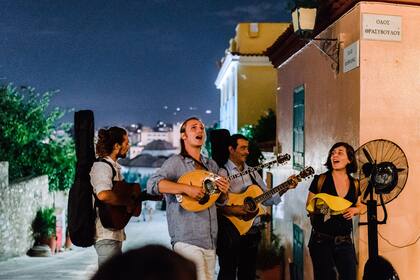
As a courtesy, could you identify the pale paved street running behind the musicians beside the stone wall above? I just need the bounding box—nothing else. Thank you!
[0,210,170,280]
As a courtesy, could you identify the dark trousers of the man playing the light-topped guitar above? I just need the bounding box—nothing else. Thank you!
[216,217,261,280]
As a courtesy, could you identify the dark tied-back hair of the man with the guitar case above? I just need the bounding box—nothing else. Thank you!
[96,126,127,157]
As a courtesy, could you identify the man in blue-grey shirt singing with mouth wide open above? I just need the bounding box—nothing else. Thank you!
[147,117,229,280]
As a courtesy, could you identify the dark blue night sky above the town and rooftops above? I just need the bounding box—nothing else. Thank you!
[0,0,290,126]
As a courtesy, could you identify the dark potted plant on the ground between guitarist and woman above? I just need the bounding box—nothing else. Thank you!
[257,234,284,280]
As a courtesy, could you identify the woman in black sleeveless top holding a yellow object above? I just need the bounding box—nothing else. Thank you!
[307,142,362,280]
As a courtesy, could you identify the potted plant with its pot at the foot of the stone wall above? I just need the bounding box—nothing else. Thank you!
[28,207,56,256]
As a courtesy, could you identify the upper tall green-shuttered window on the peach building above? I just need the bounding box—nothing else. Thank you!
[293,86,305,170]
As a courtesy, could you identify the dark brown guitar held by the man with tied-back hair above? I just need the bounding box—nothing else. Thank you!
[96,181,163,229]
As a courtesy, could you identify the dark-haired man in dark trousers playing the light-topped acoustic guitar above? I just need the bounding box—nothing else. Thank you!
[217,134,298,280]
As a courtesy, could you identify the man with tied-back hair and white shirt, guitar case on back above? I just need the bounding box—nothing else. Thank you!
[90,127,136,266]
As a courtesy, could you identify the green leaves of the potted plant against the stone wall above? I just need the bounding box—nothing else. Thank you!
[32,207,56,242]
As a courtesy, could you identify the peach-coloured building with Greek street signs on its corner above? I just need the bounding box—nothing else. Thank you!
[268,0,420,279]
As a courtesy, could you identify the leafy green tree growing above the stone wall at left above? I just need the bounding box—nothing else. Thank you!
[0,85,76,191]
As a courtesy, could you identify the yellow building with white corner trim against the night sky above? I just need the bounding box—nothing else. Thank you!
[215,23,288,133]
